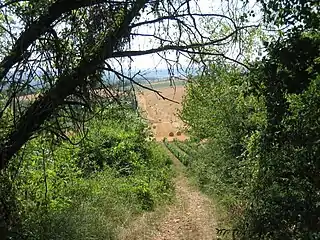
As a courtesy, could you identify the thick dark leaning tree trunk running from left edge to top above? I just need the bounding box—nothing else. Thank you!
[0,0,147,170]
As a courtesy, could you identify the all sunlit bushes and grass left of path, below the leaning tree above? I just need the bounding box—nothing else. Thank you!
[1,102,172,239]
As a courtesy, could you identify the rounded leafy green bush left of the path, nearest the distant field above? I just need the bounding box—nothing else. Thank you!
[78,106,150,175]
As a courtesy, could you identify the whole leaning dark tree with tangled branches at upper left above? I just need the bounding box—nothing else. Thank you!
[0,0,255,170]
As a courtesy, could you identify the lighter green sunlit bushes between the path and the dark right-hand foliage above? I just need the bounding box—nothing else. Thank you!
[181,65,266,221]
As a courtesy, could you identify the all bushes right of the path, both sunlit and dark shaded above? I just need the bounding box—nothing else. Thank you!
[181,26,320,239]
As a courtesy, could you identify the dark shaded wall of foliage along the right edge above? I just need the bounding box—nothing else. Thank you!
[242,34,320,239]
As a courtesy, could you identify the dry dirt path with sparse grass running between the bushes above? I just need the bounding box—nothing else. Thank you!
[120,144,216,240]
